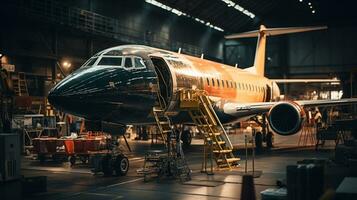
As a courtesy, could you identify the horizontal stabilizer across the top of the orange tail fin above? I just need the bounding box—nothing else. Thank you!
[225,26,327,39]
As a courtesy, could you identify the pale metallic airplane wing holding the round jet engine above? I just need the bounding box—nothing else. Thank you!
[223,98,357,117]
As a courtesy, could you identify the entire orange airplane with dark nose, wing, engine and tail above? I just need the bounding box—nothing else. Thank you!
[48,25,357,148]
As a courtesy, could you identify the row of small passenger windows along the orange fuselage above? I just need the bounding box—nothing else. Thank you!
[201,77,264,92]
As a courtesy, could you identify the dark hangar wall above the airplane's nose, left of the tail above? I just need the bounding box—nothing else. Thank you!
[0,0,223,96]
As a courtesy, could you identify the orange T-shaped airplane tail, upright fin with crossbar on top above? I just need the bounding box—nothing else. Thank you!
[225,25,327,76]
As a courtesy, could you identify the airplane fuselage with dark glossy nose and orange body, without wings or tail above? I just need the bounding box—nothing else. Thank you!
[48,45,280,124]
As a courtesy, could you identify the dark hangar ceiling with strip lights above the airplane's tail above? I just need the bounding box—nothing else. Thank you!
[158,0,357,33]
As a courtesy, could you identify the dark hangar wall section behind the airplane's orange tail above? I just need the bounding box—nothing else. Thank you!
[224,27,357,76]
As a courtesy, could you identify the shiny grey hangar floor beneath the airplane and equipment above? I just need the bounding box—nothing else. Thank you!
[22,135,334,200]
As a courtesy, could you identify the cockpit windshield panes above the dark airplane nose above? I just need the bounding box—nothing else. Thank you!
[82,56,145,68]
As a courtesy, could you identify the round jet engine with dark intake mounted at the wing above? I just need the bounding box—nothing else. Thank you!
[268,102,306,135]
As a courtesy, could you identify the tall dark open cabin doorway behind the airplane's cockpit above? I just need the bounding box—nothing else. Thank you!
[150,57,173,109]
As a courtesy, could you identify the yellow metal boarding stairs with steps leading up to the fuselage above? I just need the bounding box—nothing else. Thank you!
[180,90,240,169]
